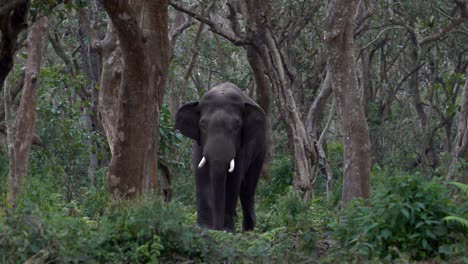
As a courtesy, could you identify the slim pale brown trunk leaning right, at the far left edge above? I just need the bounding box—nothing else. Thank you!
[8,17,48,206]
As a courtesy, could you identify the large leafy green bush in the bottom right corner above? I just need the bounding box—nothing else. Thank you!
[332,172,468,260]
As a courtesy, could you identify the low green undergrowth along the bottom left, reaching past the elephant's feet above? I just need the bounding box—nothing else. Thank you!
[0,197,322,263]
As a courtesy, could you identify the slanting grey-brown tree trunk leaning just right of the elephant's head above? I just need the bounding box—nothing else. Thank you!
[241,0,316,194]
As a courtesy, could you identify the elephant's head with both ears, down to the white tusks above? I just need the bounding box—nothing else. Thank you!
[176,83,265,172]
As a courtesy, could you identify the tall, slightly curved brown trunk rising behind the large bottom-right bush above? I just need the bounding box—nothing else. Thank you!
[325,0,371,204]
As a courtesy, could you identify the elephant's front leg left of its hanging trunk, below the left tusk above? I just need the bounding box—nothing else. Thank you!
[193,143,213,228]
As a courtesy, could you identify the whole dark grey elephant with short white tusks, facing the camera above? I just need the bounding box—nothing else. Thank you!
[175,82,266,232]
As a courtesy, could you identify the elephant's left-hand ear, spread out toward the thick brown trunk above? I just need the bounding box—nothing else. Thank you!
[175,102,200,141]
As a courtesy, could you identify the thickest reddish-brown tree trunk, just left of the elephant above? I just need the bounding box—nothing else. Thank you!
[101,0,170,197]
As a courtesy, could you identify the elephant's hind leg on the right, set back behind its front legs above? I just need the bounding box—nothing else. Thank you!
[240,156,263,231]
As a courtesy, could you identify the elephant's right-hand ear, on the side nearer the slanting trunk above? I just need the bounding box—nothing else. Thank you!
[242,103,266,144]
